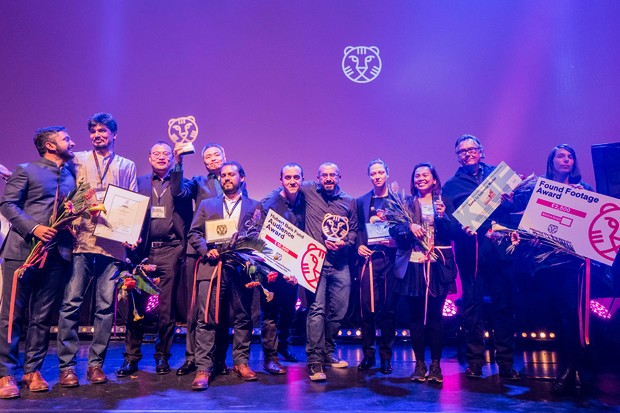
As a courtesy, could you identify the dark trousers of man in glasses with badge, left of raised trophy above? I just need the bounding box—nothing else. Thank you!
[125,245,184,361]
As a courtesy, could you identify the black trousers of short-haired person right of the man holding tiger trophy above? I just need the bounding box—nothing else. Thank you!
[360,252,398,360]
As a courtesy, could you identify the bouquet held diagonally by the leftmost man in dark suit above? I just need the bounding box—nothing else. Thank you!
[15,182,106,278]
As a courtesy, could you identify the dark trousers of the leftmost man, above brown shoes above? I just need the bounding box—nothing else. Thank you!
[0,249,71,377]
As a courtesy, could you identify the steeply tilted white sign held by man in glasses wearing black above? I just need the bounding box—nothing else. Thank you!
[452,162,521,232]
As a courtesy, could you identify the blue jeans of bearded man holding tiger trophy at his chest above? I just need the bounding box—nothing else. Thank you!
[306,265,351,364]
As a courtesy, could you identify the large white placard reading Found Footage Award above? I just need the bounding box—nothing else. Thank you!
[519,178,620,265]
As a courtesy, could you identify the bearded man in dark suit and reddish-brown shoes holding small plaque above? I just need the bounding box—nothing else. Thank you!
[189,162,258,390]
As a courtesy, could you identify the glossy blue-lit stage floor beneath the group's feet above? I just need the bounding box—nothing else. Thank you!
[0,341,620,413]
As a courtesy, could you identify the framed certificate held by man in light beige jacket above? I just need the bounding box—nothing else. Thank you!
[93,185,150,244]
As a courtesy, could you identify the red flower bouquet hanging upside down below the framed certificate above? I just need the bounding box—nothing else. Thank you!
[112,258,160,321]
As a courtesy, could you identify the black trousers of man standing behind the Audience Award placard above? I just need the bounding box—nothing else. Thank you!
[260,275,298,360]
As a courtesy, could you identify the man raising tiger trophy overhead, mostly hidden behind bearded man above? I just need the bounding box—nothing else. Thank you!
[170,143,247,376]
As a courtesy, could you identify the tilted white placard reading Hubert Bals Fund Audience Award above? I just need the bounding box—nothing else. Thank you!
[260,210,327,293]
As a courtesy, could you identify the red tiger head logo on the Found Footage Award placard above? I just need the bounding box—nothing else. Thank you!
[588,203,620,261]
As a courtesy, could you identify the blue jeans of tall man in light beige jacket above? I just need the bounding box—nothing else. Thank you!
[58,254,118,370]
